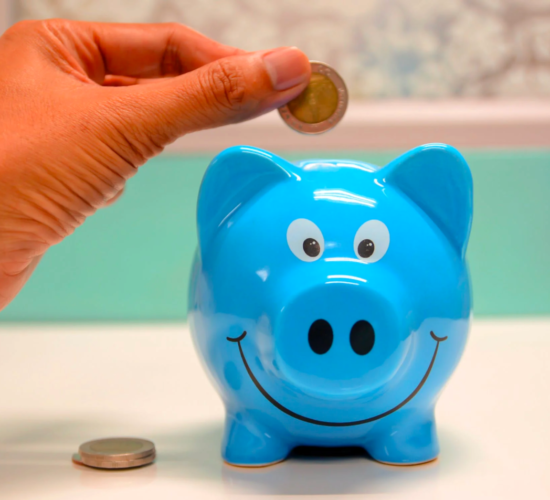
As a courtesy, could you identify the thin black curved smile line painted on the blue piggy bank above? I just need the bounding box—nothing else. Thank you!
[227,332,447,427]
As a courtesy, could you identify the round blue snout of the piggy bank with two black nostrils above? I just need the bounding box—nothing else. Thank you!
[274,282,408,397]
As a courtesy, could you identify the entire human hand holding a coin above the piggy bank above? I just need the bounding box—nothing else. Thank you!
[0,20,310,310]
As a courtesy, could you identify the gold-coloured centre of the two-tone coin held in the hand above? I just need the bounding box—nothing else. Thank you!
[287,73,338,123]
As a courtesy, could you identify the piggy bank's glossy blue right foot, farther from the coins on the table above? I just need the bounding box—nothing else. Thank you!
[363,410,439,465]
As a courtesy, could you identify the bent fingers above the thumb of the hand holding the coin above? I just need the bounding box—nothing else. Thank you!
[9,19,244,84]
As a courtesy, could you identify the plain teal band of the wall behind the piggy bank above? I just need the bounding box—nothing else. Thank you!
[0,150,550,321]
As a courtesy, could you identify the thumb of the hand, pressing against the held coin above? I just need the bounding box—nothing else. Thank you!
[105,47,311,146]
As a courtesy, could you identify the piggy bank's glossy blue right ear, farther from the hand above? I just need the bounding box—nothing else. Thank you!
[384,144,473,257]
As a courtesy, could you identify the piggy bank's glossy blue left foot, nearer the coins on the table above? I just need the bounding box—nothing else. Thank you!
[222,412,292,467]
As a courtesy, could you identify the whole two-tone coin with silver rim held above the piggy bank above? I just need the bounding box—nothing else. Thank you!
[279,61,348,134]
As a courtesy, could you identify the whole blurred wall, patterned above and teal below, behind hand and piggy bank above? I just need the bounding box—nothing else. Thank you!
[0,0,550,320]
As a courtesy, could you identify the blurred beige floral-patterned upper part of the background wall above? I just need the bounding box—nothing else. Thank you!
[15,0,550,98]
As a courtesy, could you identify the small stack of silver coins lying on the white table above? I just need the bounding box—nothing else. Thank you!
[78,437,156,468]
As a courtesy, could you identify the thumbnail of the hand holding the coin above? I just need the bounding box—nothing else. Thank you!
[263,47,309,90]
